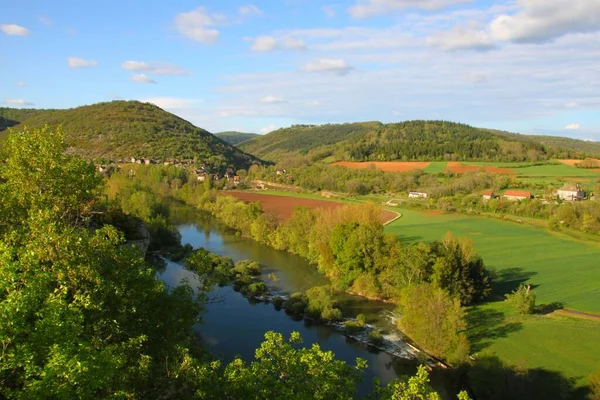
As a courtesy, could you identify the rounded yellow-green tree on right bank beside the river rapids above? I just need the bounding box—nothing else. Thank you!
[399,284,469,364]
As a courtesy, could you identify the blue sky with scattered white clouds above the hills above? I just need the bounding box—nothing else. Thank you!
[0,0,600,141]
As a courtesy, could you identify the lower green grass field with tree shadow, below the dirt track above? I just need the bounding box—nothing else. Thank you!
[468,301,600,386]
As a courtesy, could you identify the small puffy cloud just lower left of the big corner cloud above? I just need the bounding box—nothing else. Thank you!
[427,26,494,51]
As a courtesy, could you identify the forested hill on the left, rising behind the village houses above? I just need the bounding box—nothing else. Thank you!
[0,101,260,168]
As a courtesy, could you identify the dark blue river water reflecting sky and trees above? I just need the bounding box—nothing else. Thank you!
[159,213,446,397]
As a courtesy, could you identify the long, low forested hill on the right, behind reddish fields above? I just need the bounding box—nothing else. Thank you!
[239,121,600,161]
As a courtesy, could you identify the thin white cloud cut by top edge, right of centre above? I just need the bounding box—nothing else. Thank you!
[348,0,472,18]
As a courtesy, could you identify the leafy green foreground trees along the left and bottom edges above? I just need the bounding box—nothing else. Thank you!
[0,126,478,400]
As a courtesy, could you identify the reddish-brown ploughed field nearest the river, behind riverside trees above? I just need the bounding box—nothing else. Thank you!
[223,191,397,222]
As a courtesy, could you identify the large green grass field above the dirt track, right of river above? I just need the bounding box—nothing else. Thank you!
[386,210,600,312]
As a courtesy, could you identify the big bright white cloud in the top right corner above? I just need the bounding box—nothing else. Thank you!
[490,0,600,42]
